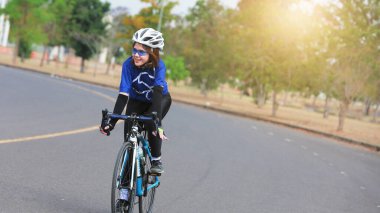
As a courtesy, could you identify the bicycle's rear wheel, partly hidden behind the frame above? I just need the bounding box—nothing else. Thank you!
[139,150,156,213]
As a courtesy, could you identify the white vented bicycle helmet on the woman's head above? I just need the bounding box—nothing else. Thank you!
[132,28,164,51]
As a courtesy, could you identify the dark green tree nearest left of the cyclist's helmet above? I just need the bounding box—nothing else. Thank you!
[68,0,110,72]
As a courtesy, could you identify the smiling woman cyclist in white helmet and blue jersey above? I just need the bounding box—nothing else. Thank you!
[100,28,171,174]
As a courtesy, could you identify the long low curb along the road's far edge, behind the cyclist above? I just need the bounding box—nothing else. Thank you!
[0,62,380,152]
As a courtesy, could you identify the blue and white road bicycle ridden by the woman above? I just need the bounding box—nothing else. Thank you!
[102,110,160,213]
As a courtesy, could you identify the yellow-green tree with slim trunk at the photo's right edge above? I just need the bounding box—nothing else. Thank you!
[319,0,380,131]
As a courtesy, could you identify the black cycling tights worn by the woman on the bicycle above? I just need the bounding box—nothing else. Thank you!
[124,93,172,158]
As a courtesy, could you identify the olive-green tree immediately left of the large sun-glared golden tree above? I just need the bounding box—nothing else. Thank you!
[182,0,230,95]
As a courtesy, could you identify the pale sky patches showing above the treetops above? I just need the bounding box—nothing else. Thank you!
[101,0,239,15]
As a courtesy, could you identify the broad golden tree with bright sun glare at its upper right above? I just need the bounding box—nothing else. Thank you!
[232,0,308,116]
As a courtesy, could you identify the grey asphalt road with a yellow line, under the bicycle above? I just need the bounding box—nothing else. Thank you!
[0,66,380,213]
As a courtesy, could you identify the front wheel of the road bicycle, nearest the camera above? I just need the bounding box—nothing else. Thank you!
[111,143,135,213]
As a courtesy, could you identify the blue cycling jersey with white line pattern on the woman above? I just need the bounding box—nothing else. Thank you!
[119,57,168,102]
